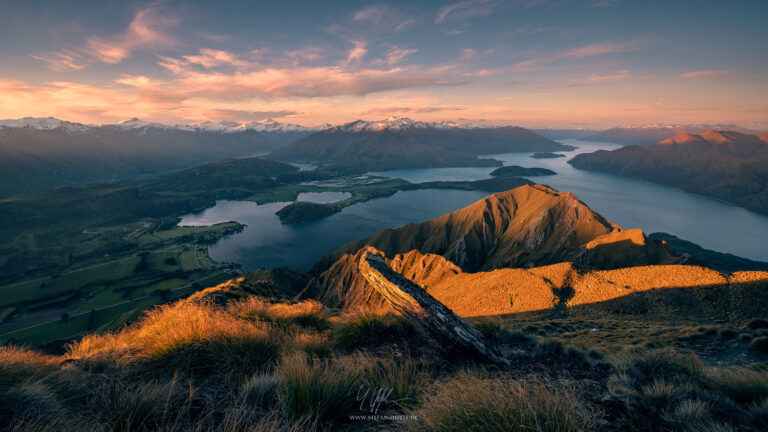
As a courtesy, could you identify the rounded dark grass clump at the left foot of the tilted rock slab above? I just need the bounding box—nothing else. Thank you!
[335,311,417,348]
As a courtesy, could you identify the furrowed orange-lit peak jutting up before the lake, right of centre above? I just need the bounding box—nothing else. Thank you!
[312,185,672,274]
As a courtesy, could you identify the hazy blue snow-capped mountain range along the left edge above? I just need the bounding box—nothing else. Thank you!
[0,118,284,197]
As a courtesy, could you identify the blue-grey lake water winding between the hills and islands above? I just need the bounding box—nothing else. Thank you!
[181,140,768,270]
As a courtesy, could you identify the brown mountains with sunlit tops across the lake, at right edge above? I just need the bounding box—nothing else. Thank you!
[568,131,768,213]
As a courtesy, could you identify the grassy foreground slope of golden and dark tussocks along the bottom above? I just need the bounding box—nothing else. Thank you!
[0,283,768,431]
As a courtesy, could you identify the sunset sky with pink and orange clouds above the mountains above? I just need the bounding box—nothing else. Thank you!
[0,0,768,129]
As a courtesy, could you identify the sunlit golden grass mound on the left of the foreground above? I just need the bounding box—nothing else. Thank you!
[67,298,324,372]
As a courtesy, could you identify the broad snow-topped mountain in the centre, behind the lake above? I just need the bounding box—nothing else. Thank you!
[269,117,575,171]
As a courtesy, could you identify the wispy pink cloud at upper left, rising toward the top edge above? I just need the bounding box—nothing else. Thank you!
[30,6,177,71]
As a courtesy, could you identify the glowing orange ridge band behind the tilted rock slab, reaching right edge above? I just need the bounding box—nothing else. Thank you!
[309,245,768,321]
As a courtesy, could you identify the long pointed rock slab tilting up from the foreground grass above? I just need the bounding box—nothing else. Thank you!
[358,250,507,365]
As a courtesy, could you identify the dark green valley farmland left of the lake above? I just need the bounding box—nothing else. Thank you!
[0,222,241,345]
